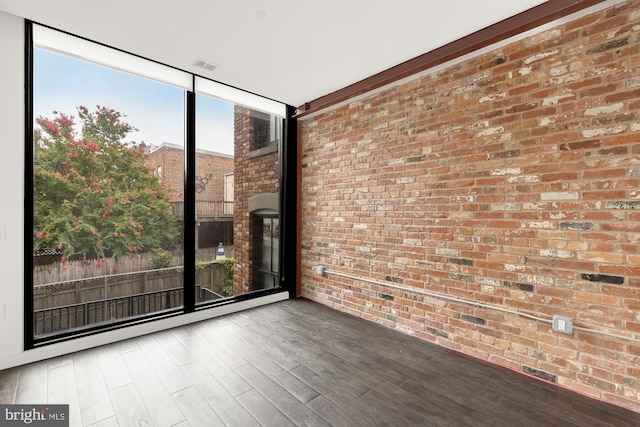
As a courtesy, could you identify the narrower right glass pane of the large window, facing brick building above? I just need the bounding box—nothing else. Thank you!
[196,94,281,303]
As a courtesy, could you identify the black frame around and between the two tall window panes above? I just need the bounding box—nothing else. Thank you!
[24,20,297,350]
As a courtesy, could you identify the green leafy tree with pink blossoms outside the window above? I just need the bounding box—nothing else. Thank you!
[34,106,180,262]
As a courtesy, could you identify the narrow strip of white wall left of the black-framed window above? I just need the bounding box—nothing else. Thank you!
[0,12,24,362]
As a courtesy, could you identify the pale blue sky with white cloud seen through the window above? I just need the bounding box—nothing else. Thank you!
[34,49,233,154]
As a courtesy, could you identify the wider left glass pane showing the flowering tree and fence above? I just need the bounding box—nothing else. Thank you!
[33,49,184,338]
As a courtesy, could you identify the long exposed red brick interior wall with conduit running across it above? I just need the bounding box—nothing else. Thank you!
[300,1,640,411]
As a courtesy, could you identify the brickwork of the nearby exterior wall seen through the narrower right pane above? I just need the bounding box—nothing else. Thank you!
[233,106,280,294]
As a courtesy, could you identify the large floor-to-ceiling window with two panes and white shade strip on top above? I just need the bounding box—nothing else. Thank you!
[27,25,292,346]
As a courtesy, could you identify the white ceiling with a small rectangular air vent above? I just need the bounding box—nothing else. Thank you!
[0,0,544,106]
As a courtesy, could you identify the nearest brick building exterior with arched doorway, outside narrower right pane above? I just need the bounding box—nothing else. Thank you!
[233,105,280,294]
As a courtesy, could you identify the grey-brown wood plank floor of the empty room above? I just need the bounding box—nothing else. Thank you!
[0,299,640,427]
